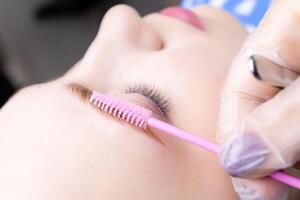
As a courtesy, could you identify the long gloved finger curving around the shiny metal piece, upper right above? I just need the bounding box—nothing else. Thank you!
[217,0,300,143]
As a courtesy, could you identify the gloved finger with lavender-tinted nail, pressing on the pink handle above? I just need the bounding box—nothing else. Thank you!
[220,78,300,177]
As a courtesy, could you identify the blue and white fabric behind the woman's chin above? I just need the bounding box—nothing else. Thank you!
[180,0,271,30]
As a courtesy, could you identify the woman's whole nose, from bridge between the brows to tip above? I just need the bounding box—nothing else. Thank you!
[66,6,162,91]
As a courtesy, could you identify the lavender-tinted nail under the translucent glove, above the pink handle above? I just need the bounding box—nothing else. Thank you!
[220,133,269,177]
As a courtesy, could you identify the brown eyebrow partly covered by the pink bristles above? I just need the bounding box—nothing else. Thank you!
[66,83,165,146]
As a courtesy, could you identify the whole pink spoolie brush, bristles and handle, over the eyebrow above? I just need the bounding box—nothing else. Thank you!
[90,91,300,189]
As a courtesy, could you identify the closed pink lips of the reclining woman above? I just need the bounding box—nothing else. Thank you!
[159,7,204,30]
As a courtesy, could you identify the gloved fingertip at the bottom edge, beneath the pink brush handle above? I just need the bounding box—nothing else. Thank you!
[231,178,289,200]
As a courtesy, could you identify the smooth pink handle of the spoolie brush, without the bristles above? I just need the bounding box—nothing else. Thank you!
[147,118,300,189]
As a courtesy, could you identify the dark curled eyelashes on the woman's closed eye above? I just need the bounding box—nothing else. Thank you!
[125,85,170,116]
